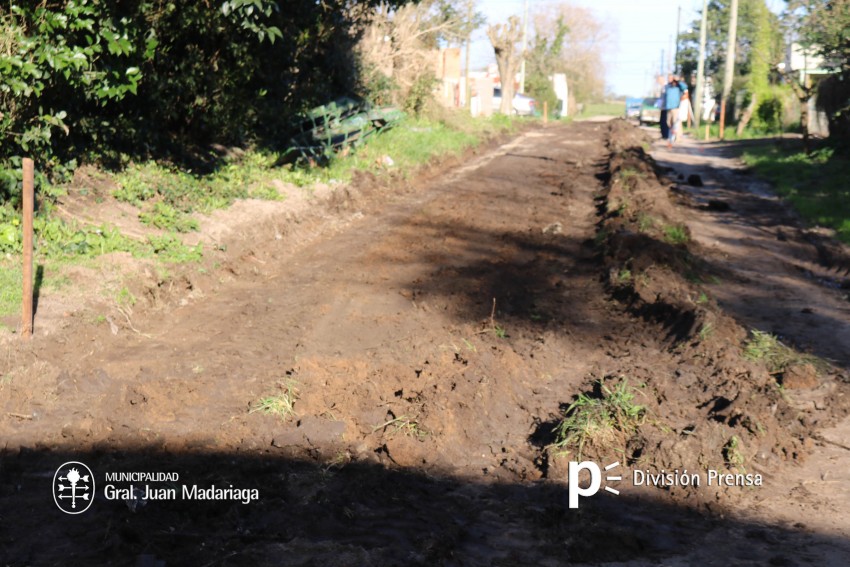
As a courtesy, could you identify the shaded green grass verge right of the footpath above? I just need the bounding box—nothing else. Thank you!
[742,146,850,244]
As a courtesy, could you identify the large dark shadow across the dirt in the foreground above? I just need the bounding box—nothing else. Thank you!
[0,448,850,566]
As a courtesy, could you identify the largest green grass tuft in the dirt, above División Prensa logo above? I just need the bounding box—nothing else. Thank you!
[551,379,646,460]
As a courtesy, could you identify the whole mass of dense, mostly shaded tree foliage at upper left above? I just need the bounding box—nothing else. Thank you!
[0,0,410,191]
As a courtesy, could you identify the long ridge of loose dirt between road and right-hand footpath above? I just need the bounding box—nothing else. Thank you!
[600,121,848,510]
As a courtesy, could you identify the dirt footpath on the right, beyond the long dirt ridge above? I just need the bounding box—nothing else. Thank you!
[652,130,850,565]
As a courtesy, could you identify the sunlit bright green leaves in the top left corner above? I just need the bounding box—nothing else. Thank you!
[0,2,144,155]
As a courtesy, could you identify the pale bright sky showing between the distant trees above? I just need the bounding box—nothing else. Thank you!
[471,0,785,96]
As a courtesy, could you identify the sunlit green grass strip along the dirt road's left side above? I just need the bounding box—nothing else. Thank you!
[0,112,510,315]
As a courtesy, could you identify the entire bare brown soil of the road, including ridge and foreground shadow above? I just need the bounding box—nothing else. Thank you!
[0,121,850,566]
